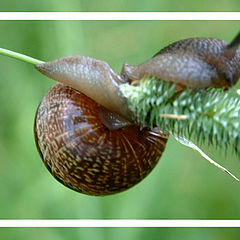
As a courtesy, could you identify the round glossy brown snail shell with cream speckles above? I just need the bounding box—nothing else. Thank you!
[34,84,167,195]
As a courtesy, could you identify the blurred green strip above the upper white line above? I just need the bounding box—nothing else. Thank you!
[0,0,240,12]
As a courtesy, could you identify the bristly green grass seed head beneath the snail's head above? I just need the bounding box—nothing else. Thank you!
[120,77,240,156]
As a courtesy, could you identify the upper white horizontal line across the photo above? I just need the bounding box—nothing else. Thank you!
[0,12,240,20]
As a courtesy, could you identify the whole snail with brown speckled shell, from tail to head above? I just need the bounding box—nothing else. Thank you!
[34,31,240,196]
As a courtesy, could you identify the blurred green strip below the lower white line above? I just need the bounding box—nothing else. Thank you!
[0,228,240,240]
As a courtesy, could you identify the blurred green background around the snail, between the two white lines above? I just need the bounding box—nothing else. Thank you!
[0,18,240,239]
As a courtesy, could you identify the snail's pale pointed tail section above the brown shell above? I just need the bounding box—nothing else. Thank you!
[35,56,131,119]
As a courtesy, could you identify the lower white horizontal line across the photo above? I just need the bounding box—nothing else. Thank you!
[0,219,240,228]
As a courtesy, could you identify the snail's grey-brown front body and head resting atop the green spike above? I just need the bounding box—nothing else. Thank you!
[122,35,240,88]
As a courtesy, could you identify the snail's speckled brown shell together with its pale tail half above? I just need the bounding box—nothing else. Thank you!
[34,56,168,195]
